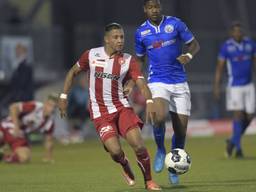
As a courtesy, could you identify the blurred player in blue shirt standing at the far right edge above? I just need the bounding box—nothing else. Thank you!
[214,22,256,158]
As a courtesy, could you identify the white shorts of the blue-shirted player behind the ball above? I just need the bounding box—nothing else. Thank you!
[148,82,191,116]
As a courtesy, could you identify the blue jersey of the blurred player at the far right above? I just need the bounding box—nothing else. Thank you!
[218,37,256,86]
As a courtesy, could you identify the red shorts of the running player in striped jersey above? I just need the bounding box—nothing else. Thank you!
[93,107,143,142]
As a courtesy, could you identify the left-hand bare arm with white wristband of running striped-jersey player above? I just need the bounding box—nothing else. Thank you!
[58,64,82,117]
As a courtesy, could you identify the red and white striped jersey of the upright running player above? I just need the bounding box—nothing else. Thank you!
[77,47,143,119]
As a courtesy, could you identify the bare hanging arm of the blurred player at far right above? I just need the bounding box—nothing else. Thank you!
[213,59,225,101]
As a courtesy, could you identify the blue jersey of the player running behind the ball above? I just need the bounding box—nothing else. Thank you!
[135,16,194,84]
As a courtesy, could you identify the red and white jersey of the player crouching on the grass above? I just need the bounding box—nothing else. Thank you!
[0,101,54,134]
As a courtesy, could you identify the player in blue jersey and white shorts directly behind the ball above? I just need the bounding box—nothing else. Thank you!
[135,0,200,184]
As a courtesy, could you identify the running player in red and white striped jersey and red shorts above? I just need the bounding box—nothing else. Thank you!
[59,23,161,191]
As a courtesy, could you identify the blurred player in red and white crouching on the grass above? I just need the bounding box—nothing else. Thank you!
[0,95,58,162]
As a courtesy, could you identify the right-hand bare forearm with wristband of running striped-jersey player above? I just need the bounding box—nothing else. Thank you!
[136,78,156,125]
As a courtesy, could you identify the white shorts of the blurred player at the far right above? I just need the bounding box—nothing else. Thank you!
[226,83,255,114]
